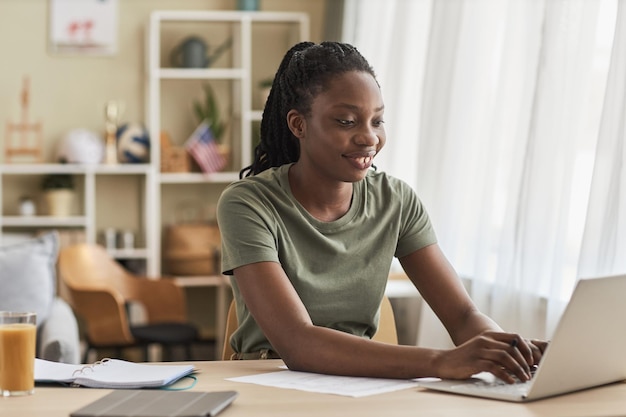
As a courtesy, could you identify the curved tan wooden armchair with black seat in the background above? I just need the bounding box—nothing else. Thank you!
[58,243,198,362]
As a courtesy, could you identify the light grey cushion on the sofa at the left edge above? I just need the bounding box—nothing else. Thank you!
[0,232,58,326]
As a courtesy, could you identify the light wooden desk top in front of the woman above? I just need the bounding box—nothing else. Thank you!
[0,360,626,417]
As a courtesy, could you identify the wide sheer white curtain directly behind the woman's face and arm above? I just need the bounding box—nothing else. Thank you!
[344,0,614,346]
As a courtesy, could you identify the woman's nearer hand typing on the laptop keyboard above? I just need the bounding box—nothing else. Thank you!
[435,332,538,383]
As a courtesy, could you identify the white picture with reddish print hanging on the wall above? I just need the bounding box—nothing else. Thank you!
[49,0,118,55]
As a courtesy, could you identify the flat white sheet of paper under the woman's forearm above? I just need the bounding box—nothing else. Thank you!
[228,370,418,397]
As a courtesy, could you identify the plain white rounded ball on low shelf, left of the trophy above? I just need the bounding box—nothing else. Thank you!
[57,129,104,164]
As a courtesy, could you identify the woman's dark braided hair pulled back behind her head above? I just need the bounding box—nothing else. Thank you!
[239,42,376,178]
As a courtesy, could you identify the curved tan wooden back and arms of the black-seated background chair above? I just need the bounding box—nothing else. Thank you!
[57,244,186,346]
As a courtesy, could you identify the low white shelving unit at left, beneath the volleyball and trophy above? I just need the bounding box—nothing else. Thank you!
[0,163,155,272]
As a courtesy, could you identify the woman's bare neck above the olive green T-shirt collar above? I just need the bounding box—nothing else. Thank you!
[288,164,353,222]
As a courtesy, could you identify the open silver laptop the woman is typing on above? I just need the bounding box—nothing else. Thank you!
[419,275,626,402]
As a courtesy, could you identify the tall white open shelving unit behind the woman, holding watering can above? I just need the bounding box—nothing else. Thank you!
[146,10,309,275]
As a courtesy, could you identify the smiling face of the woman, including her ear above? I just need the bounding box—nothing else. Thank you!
[288,71,386,182]
